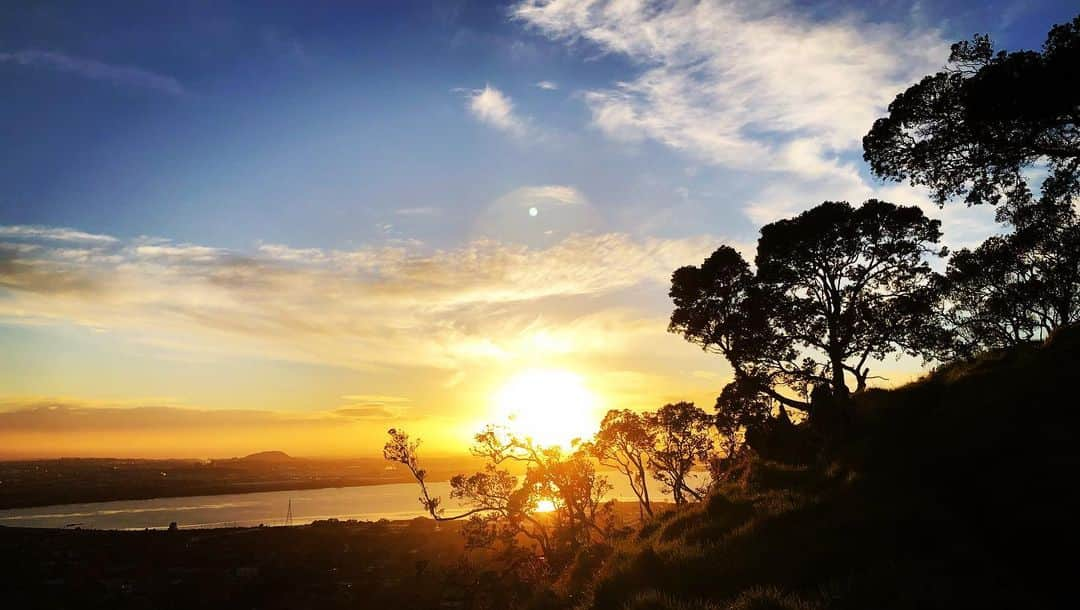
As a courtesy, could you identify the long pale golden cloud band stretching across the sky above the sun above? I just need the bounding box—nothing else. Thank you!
[0,225,717,371]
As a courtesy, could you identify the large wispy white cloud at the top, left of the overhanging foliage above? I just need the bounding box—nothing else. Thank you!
[511,0,948,173]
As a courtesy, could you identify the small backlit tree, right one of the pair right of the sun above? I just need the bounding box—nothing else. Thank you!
[645,403,713,504]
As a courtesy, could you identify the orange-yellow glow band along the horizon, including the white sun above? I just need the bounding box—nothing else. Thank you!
[0,356,933,460]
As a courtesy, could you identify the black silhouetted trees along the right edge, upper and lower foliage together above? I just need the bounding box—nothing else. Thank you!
[863,17,1080,351]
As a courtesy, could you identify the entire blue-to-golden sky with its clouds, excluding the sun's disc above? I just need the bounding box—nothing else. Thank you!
[0,0,1076,458]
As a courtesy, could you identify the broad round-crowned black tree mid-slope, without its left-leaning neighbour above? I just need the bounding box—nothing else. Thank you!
[755,199,946,395]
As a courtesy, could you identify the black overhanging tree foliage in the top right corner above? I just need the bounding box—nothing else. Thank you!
[863,16,1080,210]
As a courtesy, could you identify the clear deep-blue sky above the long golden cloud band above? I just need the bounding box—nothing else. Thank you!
[0,2,1071,247]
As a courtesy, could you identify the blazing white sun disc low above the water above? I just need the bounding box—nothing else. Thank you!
[494,368,597,449]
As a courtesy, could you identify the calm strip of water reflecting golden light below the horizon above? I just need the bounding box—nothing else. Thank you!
[0,474,699,529]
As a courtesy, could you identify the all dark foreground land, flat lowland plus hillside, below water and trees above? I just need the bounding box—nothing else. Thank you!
[0,328,1080,610]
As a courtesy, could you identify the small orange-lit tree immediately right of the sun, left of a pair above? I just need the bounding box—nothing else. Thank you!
[584,409,654,518]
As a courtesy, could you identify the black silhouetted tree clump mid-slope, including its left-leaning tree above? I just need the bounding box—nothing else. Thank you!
[669,200,945,410]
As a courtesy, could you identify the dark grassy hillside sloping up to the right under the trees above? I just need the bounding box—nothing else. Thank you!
[561,328,1080,610]
